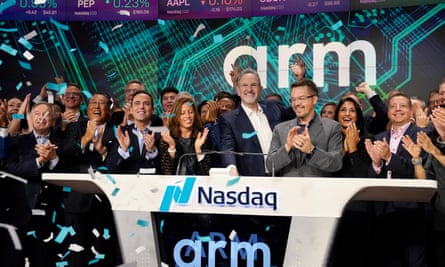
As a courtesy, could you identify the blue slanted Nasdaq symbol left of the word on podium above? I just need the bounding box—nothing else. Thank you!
[159,177,196,211]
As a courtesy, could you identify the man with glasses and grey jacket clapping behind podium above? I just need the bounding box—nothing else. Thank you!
[266,79,343,177]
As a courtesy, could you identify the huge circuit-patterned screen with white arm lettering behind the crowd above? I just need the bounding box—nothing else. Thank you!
[0,3,445,112]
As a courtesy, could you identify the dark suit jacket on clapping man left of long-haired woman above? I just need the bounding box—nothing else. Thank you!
[106,125,160,174]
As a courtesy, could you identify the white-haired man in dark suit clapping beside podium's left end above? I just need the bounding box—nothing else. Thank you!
[5,103,63,266]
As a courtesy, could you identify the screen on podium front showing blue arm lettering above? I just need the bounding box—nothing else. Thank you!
[154,213,291,267]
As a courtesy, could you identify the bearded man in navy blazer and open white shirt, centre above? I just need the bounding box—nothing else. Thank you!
[218,69,281,176]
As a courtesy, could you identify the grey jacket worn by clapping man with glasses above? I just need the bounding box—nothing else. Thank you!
[266,115,343,177]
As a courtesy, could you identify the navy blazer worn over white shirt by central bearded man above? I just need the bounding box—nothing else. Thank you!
[218,101,281,176]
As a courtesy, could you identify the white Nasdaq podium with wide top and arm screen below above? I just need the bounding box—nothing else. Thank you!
[43,172,437,267]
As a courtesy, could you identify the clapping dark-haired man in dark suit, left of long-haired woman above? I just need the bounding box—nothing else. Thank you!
[106,91,159,174]
